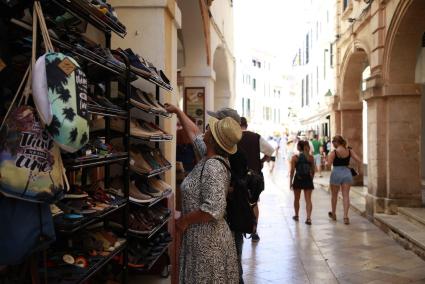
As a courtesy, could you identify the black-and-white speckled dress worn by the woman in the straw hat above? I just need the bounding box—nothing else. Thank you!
[180,137,239,284]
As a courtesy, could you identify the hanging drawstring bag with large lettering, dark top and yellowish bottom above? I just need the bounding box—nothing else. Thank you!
[0,65,68,202]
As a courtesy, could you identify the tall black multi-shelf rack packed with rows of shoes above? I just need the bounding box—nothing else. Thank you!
[7,0,173,283]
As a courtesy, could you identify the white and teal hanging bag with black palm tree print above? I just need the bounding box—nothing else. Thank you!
[32,1,89,153]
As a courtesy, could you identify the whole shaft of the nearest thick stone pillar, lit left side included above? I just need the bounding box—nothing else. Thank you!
[367,84,421,215]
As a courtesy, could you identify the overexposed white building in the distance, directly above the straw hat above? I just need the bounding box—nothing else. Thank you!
[234,51,290,137]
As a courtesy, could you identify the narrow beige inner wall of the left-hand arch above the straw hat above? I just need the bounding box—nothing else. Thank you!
[213,46,232,109]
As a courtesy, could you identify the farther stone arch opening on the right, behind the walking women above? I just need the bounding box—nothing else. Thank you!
[339,47,369,185]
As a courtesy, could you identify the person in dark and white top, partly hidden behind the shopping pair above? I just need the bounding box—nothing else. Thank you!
[238,117,274,242]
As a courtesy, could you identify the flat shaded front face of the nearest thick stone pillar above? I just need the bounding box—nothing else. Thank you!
[386,88,422,210]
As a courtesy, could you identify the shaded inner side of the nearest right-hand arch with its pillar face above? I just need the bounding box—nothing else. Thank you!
[383,0,425,209]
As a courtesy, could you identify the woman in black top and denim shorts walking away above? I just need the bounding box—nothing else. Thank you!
[328,135,361,225]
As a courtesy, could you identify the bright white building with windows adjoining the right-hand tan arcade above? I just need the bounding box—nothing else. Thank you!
[292,0,335,137]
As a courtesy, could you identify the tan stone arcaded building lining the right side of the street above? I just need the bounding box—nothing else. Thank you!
[329,0,425,215]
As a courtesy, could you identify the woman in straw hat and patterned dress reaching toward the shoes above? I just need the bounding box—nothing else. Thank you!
[166,104,242,283]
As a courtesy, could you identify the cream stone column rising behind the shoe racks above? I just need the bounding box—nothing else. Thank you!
[111,0,181,188]
